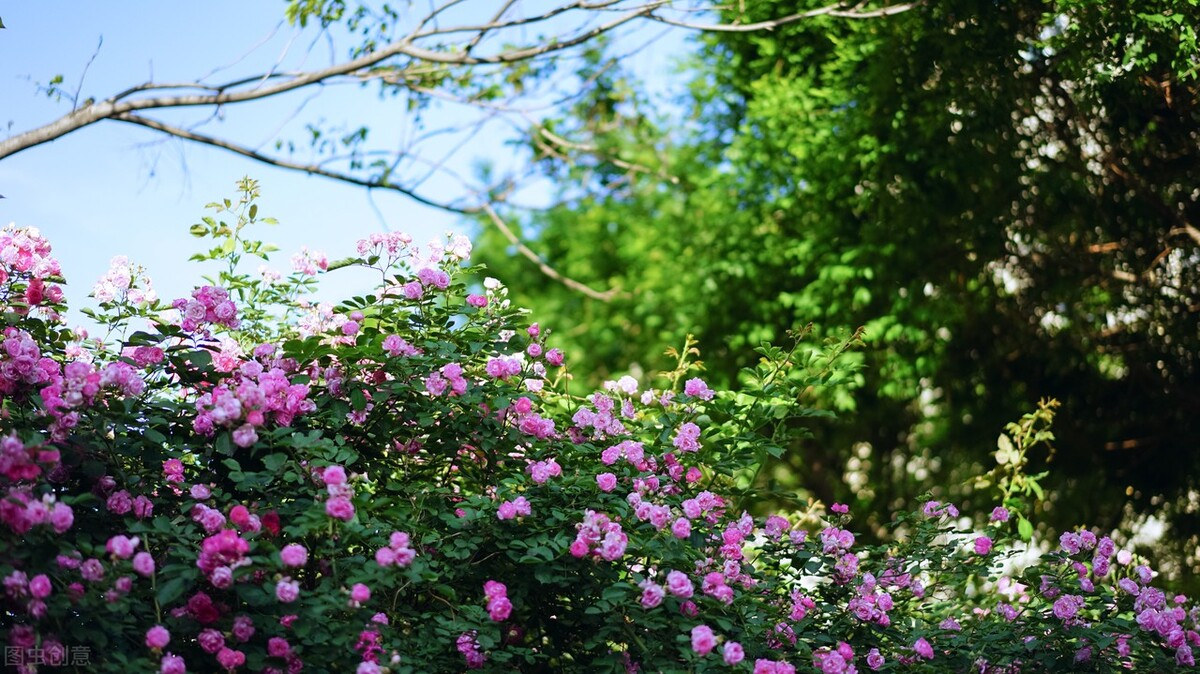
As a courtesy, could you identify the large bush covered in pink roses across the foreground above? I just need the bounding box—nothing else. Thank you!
[0,182,1200,674]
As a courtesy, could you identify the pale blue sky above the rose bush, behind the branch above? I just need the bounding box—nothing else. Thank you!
[0,0,684,321]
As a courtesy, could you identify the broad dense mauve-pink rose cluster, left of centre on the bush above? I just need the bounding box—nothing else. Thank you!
[192,344,317,447]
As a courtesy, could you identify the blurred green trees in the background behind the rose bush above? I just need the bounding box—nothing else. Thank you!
[476,0,1200,589]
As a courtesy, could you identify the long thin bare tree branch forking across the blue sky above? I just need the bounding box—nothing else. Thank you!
[0,0,912,301]
